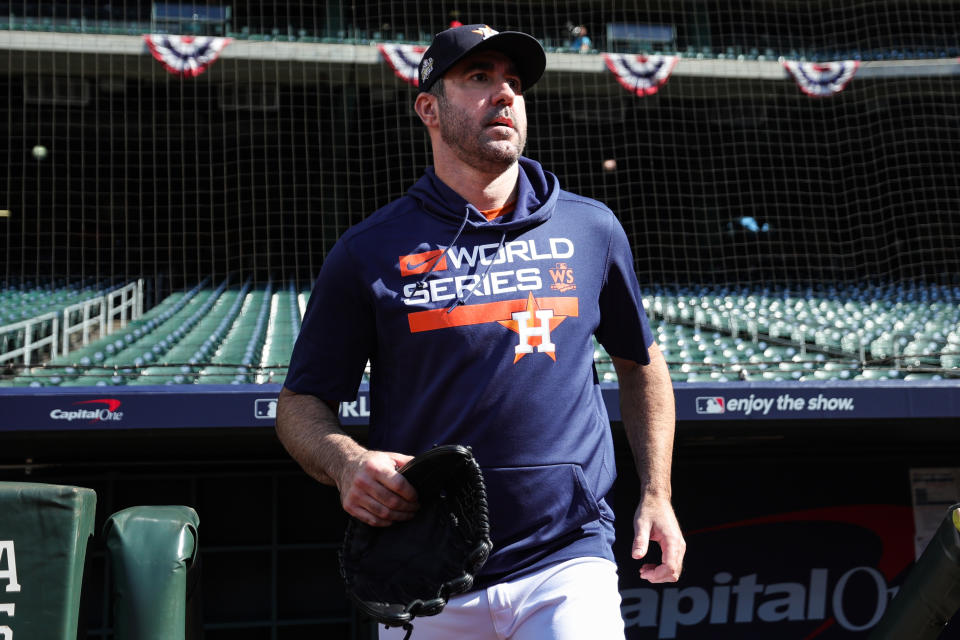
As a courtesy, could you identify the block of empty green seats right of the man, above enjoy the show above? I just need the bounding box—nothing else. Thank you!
[644,284,960,382]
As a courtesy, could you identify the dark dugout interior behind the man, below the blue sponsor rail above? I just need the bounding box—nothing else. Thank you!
[0,384,960,638]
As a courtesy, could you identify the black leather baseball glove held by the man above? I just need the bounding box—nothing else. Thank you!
[340,445,493,638]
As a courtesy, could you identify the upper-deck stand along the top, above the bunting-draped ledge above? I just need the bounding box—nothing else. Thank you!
[0,0,960,61]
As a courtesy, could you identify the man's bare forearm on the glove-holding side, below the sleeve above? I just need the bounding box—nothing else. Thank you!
[277,389,366,485]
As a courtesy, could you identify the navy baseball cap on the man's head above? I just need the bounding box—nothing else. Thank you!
[417,24,547,91]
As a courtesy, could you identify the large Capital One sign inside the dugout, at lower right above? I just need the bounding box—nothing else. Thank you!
[621,505,913,640]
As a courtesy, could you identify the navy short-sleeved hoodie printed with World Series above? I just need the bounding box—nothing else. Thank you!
[285,158,653,587]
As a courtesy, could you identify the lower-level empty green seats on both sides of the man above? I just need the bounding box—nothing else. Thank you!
[0,280,960,387]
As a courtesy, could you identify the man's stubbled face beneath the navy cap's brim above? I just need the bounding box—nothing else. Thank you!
[438,51,527,173]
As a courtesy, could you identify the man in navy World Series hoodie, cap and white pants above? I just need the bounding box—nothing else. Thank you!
[277,25,685,640]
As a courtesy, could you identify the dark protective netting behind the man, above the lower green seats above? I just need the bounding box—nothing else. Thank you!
[0,0,960,380]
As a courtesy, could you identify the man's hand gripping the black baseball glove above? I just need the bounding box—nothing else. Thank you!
[337,451,419,527]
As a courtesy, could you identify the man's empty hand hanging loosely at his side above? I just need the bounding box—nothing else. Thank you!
[631,496,687,582]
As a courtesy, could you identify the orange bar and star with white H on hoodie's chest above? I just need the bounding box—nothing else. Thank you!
[407,292,580,364]
